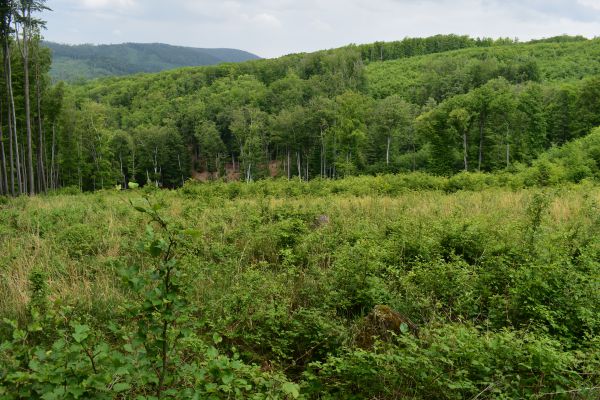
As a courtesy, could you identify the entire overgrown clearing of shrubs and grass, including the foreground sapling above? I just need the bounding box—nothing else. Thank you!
[0,172,600,399]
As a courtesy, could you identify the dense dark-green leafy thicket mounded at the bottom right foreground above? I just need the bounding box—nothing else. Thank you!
[306,325,584,399]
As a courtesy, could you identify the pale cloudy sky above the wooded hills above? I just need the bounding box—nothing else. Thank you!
[43,0,600,58]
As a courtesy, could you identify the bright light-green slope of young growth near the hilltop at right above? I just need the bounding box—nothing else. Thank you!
[367,37,600,102]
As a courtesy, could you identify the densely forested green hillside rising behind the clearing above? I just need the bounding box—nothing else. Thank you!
[39,36,600,190]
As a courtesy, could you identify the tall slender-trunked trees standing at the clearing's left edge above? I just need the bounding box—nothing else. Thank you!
[0,0,56,196]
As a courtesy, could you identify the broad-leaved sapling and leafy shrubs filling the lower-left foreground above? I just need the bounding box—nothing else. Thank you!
[0,200,299,399]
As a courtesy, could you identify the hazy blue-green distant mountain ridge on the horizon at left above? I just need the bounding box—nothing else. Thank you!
[44,42,260,82]
